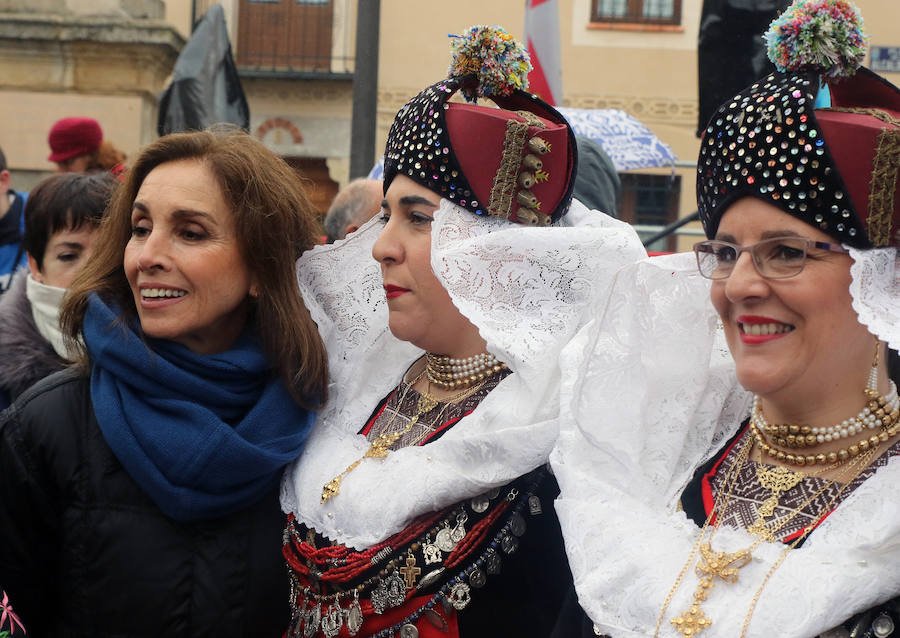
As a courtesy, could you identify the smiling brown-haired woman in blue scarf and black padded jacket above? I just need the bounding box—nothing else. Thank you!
[0,130,327,636]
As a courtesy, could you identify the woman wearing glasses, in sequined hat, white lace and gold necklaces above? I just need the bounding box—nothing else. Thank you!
[551,0,900,638]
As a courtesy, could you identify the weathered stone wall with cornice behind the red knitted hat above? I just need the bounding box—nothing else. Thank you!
[0,0,185,175]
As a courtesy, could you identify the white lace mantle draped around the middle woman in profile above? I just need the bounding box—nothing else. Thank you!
[281,200,646,549]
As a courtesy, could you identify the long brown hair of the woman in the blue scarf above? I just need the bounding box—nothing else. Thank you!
[60,126,328,408]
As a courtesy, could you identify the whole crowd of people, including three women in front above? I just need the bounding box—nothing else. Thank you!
[0,0,900,638]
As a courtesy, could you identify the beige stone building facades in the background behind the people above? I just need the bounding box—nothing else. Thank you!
[0,0,900,238]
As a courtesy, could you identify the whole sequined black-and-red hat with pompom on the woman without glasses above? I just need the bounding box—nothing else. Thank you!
[384,26,577,226]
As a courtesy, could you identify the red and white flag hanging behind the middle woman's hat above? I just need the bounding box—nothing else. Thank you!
[525,0,562,106]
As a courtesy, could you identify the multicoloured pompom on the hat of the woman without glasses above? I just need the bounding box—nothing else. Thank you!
[447,25,531,102]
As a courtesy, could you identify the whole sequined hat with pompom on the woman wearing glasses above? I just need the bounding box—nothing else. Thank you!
[697,0,900,249]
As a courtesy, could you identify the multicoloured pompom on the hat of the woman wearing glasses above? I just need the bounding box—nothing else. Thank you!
[765,0,866,80]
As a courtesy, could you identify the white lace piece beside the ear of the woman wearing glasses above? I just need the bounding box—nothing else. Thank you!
[847,246,900,350]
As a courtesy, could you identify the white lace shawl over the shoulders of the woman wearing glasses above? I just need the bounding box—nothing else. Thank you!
[551,255,900,638]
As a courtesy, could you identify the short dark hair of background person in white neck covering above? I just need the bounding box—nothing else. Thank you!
[23,173,118,269]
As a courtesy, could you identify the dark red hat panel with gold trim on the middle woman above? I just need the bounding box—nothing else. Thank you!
[445,103,570,225]
